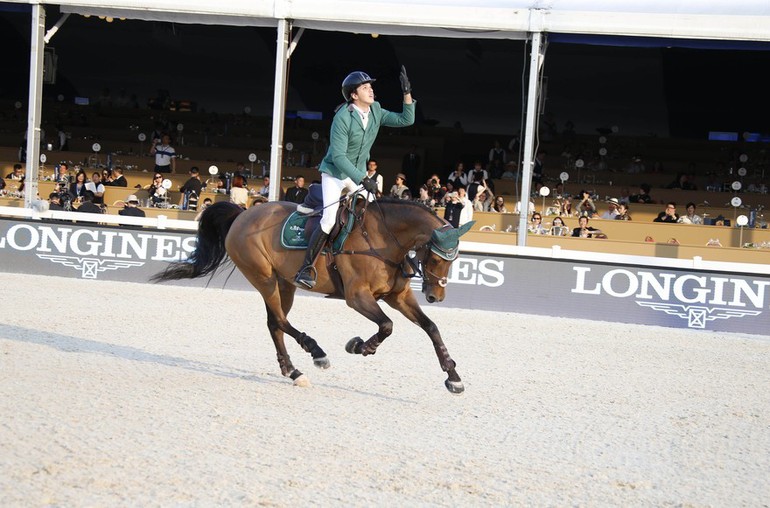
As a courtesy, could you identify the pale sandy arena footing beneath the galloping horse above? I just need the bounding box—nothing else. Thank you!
[0,274,770,506]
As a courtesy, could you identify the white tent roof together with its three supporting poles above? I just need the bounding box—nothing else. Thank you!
[10,0,770,245]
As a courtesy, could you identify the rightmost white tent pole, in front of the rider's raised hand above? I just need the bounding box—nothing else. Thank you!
[516,32,542,247]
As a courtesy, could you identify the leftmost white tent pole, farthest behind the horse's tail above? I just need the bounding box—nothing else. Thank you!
[24,3,45,208]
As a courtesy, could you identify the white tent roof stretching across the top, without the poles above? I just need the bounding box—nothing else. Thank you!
[0,0,756,41]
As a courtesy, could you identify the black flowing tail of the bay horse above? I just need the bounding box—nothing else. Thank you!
[150,201,243,282]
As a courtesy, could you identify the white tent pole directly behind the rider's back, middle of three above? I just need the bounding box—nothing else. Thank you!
[269,19,291,201]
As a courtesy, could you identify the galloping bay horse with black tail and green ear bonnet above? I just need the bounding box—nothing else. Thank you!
[152,199,472,394]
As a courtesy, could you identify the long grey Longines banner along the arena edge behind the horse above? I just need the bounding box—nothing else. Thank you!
[0,219,770,335]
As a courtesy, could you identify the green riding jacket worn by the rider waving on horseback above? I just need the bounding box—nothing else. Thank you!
[318,102,415,183]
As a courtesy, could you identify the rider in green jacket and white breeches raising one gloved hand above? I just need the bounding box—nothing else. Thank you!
[294,66,415,289]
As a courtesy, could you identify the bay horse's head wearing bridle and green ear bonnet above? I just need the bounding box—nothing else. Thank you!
[414,221,474,303]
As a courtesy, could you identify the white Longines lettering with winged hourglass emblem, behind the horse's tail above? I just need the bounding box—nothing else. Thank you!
[0,224,195,279]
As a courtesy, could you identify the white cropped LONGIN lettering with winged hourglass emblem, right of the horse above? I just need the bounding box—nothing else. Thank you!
[572,266,770,328]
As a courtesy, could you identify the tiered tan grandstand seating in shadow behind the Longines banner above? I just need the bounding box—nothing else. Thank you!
[0,98,770,260]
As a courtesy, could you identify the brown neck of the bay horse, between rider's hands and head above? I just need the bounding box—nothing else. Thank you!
[367,201,444,250]
